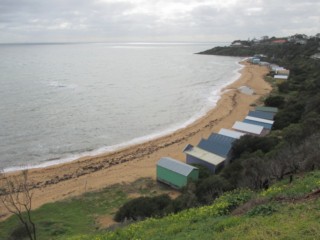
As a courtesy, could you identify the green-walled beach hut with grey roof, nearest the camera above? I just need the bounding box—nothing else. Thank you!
[157,157,199,189]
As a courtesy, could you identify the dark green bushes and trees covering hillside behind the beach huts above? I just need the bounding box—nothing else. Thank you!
[108,34,320,225]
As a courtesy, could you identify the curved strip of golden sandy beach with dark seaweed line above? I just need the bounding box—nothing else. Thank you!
[0,63,271,220]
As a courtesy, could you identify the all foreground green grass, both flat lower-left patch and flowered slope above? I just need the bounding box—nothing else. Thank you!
[0,171,320,240]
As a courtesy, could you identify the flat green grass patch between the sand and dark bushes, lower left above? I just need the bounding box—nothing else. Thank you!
[0,178,171,240]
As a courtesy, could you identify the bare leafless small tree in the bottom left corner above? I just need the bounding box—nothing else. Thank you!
[0,170,37,240]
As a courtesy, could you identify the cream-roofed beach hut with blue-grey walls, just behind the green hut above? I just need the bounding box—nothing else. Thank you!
[183,144,225,173]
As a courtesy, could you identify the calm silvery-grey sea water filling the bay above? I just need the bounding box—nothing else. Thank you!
[0,43,240,170]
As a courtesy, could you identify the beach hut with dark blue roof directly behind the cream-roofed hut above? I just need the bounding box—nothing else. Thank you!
[198,133,236,158]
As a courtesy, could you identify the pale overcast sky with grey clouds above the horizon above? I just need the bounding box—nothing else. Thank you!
[0,0,320,43]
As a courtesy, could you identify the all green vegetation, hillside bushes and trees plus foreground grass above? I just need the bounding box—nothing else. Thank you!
[0,33,320,239]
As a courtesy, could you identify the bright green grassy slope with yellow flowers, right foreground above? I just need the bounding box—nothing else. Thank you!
[64,171,320,240]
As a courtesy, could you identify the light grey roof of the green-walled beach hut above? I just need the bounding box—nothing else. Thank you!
[157,157,197,176]
